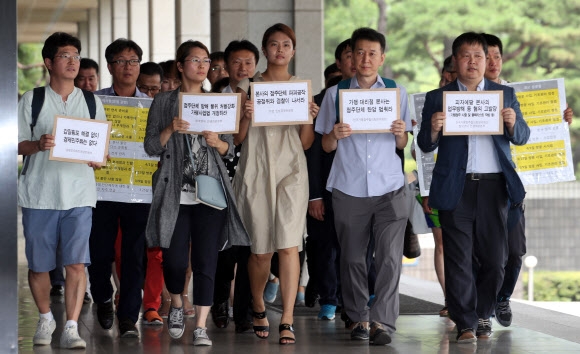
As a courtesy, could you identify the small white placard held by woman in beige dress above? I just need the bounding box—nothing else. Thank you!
[251,80,313,127]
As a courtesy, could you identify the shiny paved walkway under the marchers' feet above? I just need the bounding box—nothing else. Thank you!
[14,207,580,354]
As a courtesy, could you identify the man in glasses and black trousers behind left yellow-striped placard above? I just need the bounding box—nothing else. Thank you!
[89,38,150,338]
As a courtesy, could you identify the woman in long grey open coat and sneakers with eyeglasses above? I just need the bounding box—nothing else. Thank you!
[145,41,249,345]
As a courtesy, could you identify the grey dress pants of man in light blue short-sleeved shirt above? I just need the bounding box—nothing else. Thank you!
[332,186,409,333]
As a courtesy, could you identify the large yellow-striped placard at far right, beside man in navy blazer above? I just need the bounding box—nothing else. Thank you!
[507,79,576,185]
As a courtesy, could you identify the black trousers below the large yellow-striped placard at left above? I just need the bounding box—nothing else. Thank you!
[89,202,150,322]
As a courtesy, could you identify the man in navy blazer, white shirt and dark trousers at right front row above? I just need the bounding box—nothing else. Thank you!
[417,32,530,343]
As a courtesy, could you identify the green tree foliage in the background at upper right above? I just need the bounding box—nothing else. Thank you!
[325,0,580,172]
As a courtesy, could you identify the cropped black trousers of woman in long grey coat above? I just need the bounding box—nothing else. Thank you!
[161,204,227,306]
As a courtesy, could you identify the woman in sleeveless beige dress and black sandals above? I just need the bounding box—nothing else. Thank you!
[234,23,318,344]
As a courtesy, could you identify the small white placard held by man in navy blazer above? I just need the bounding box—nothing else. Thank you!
[443,91,504,135]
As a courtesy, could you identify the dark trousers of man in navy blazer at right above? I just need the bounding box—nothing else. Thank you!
[439,178,508,332]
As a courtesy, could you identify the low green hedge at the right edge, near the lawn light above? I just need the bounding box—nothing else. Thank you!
[522,271,580,301]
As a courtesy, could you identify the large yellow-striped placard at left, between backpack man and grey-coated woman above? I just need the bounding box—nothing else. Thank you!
[95,96,154,203]
